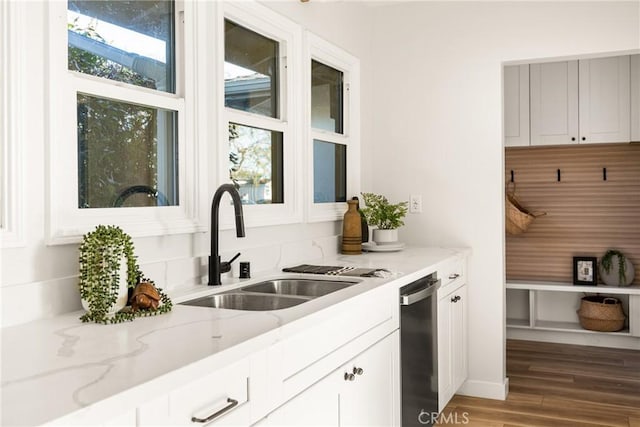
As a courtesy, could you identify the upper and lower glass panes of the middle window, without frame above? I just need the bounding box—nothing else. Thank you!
[224,19,284,204]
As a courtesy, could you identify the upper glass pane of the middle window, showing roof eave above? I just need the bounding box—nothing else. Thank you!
[224,20,279,118]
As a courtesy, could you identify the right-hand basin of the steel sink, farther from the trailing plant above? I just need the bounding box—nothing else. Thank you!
[242,278,358,298]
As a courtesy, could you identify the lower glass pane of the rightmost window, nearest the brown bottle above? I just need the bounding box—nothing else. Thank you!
[313,139,347,203]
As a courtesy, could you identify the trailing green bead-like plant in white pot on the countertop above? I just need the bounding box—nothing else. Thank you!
[78,225,172,323]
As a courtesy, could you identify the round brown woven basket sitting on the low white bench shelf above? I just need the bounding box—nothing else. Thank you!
[577,295,626,332]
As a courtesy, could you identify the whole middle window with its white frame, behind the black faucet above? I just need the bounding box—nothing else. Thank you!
[219,2,303,226]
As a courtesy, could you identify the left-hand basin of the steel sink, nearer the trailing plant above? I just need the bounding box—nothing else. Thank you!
[181,292,309,311]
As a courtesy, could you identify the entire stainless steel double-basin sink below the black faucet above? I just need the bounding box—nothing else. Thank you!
[181,278,358,311]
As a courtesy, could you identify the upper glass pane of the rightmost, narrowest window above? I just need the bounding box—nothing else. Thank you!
[311,61,343,133]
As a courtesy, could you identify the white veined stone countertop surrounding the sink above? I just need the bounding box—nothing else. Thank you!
[0,248,465,425]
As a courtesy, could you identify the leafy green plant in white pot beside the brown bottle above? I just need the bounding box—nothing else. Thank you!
[361,193,409,245]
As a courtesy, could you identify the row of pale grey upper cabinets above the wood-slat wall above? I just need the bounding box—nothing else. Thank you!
[504,55,640,147]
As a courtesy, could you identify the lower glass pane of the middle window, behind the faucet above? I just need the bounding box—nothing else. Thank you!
[229,123,284,205]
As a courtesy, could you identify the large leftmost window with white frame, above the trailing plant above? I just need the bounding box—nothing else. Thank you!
[49,0,200,243]
